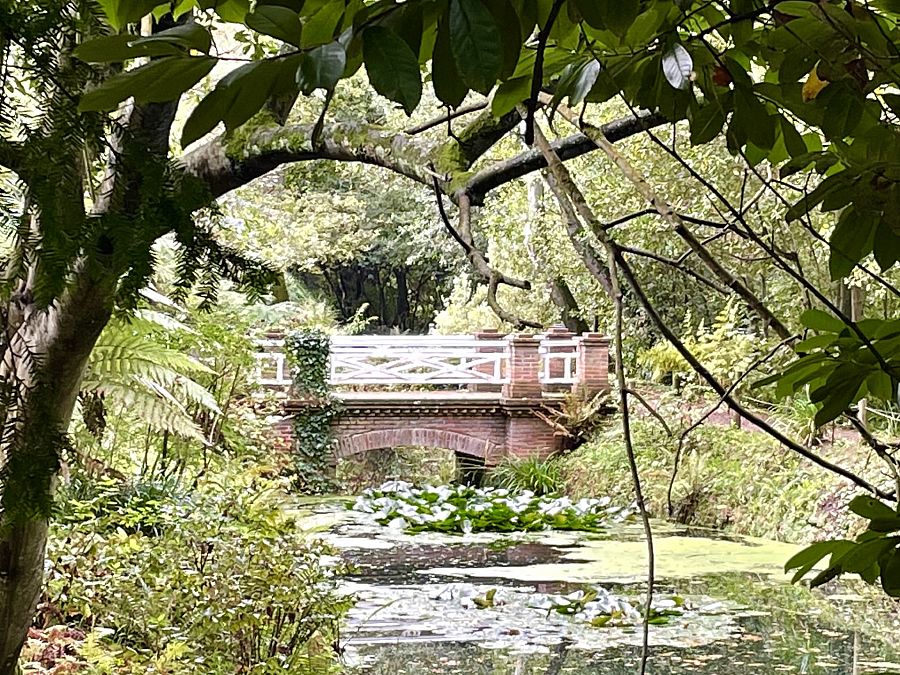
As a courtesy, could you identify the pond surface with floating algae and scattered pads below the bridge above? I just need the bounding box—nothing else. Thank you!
[301,501,900,675]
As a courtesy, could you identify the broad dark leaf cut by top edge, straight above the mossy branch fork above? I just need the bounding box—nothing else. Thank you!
[450,0,504,95]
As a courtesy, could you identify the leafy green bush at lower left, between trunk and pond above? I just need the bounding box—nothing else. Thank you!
[39,472,352,675]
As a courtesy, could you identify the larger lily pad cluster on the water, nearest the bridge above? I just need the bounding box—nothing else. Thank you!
[353,480,634,534]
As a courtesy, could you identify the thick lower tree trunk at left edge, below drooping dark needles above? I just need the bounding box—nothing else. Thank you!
[0,272,115,675]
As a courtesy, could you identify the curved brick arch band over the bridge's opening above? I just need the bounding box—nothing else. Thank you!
[336,427,503,459]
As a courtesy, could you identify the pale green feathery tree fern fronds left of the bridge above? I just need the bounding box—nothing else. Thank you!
[82,319,221,442]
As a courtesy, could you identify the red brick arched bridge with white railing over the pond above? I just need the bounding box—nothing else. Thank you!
[256,327,609,466]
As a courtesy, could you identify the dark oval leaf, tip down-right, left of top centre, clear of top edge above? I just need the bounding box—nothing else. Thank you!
[363,26,422,115]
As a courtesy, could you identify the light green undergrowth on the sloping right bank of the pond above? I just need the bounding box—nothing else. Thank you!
[555,419,853,542]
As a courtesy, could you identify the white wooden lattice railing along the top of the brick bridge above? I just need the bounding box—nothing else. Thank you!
[255,335,578,387]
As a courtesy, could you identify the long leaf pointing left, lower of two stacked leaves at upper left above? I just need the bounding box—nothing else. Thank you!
[78,56,218,111]
